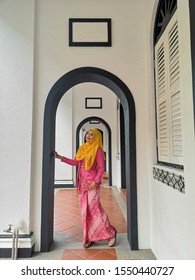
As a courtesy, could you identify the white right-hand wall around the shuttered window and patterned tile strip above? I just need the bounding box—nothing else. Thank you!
[148,0,195,259]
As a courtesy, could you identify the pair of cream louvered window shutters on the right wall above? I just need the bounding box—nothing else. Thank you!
[155,13,183,165]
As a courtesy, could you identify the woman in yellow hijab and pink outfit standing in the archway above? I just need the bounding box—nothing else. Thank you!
[54,128,117,248]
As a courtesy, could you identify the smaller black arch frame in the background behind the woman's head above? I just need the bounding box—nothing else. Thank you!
[76,116,112,186]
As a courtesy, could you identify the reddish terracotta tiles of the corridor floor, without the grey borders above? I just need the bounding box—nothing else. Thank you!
[54,187,127,260]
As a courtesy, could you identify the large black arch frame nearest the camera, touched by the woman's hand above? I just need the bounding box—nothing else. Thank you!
[41,67,138,252]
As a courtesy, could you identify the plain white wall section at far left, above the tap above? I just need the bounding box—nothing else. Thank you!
[0,0,34,233]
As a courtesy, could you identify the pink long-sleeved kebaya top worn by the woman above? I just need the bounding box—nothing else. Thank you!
[61,148,104,191]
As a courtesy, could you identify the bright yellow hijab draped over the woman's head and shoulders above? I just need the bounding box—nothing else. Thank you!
[76,128,103,170]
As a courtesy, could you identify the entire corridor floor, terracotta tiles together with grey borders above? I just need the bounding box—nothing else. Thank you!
[32,177,155,260]
